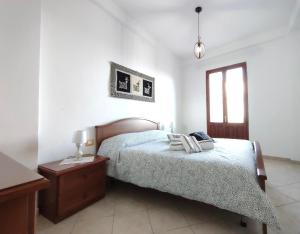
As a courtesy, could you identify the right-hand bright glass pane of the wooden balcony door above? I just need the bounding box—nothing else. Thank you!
[226,67,245,123]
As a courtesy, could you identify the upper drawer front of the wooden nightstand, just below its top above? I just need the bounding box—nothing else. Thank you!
[59,164,106,194]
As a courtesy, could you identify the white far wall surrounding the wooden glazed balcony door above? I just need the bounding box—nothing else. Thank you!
[182,32,300,160]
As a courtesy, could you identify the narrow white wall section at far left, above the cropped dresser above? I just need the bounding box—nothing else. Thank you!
[0,0,40,168]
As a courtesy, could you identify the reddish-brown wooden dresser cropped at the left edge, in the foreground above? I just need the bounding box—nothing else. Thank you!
[0,153,49,234]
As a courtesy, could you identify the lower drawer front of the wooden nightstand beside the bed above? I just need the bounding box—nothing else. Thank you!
[58,184,104,216]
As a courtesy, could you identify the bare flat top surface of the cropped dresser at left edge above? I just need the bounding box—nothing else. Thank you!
[0,153,44,192]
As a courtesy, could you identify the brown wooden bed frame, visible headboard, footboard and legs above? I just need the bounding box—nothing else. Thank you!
[95,118,267,234]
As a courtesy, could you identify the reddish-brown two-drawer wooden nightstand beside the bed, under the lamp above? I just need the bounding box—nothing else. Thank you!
[38,155,109,223]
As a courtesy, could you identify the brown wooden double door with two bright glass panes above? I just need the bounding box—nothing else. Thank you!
[206,63,249,139]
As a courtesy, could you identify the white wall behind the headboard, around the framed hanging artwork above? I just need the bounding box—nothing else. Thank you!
[39,0,181,163]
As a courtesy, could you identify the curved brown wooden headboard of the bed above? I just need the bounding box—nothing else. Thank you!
[95,118,159,151]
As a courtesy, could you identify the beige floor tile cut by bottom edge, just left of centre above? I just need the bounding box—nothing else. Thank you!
[113,211,152,234]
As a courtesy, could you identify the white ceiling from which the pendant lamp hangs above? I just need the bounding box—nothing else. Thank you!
[114,0,299,59]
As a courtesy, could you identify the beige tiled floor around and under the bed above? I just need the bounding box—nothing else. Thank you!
[38,159,300,234]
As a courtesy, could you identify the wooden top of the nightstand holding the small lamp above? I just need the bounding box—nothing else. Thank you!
[39,155,109,175]
